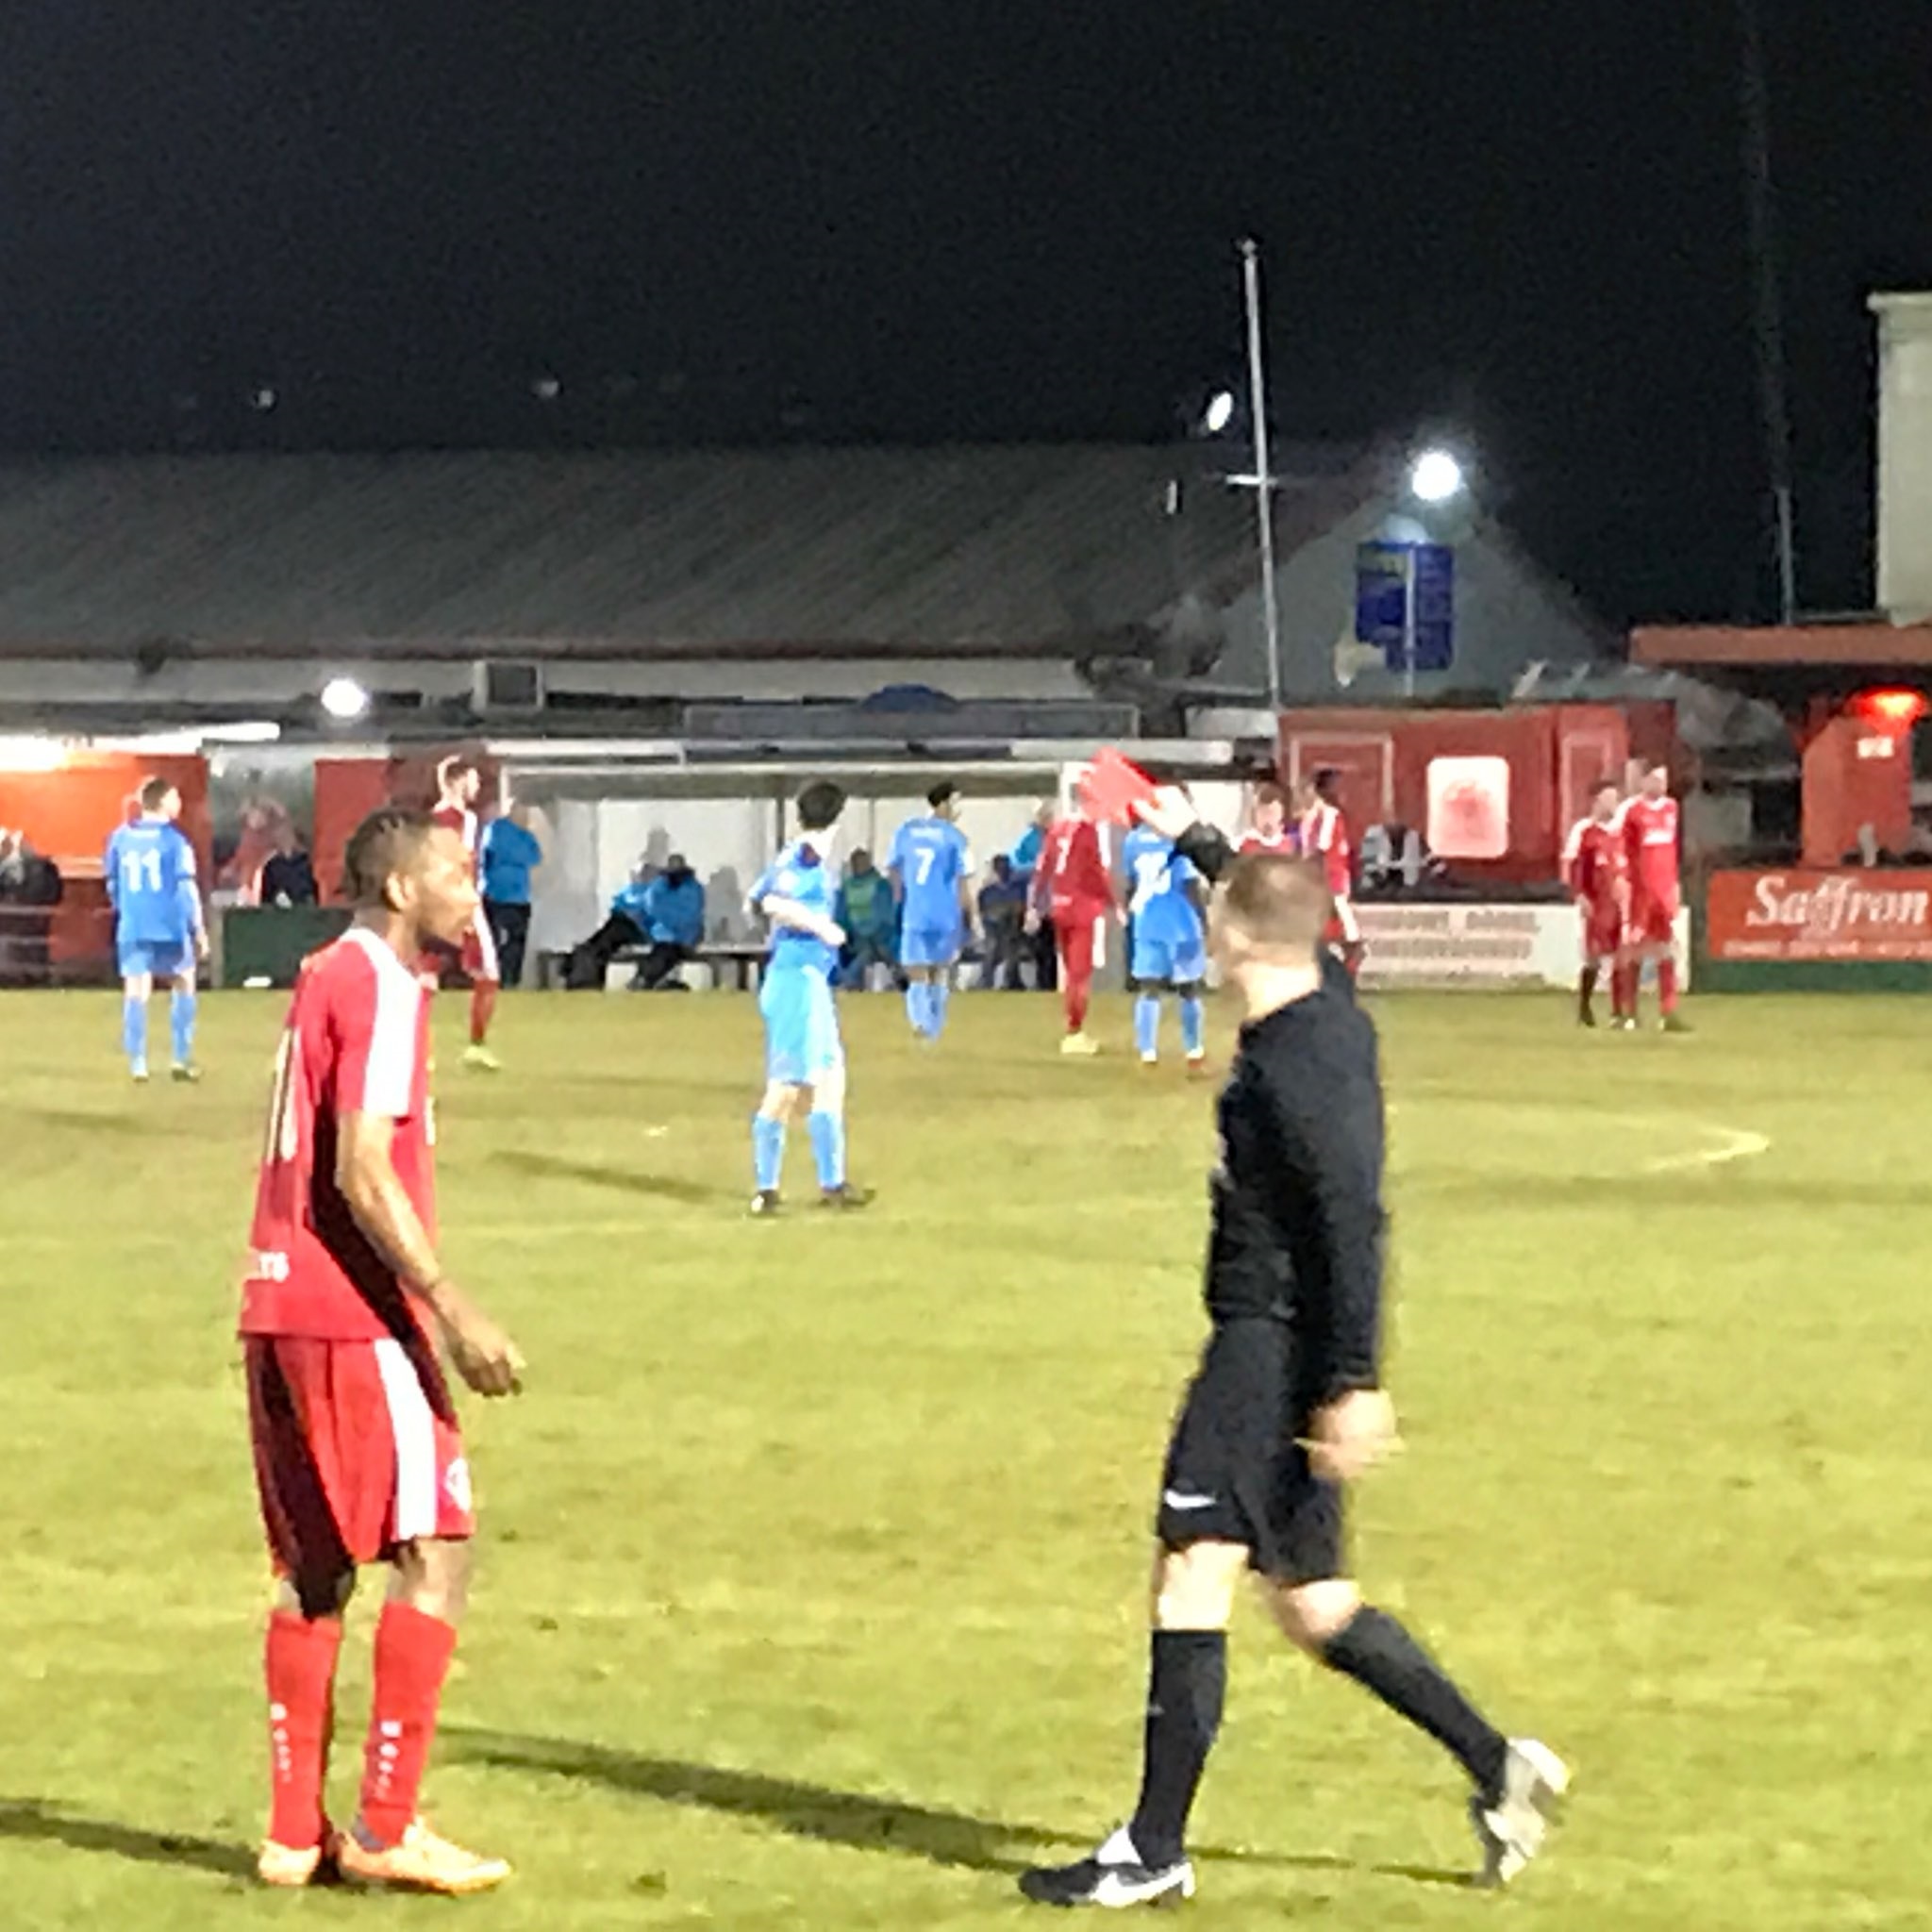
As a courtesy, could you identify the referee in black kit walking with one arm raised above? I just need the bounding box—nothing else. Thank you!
[1020,792,1569,1907]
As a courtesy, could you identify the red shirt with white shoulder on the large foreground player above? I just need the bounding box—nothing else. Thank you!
[242,925,437,1341]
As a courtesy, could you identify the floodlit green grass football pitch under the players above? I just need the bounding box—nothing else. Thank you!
[0,993,1932,1932]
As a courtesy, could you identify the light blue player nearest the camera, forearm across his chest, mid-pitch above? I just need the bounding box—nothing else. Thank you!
[748,778,872,1215]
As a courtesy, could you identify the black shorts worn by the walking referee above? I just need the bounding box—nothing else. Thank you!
[1154,1320,1346,1584]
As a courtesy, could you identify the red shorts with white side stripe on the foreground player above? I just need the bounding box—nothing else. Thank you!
[247,1335,475,1576]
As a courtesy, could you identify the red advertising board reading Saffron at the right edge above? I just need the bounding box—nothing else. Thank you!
[1706,866,1932,962]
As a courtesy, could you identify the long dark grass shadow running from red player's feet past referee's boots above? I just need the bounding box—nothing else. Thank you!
[442,1727,1474,1888]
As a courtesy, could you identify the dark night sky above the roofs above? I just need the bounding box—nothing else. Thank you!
[0,0,1932,618]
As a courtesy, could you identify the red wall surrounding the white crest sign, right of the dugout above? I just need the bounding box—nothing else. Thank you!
[1281,703,1677,885]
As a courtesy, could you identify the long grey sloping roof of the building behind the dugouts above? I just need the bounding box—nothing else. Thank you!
[0,446,1349,655]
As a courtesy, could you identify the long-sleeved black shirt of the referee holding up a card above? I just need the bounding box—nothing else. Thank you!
[1180,827,1385,1401]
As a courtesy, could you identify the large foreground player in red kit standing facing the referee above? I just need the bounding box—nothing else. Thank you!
[242,806,522,1893]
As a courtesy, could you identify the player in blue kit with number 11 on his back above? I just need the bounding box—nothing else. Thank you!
[103,778,208,1080]
